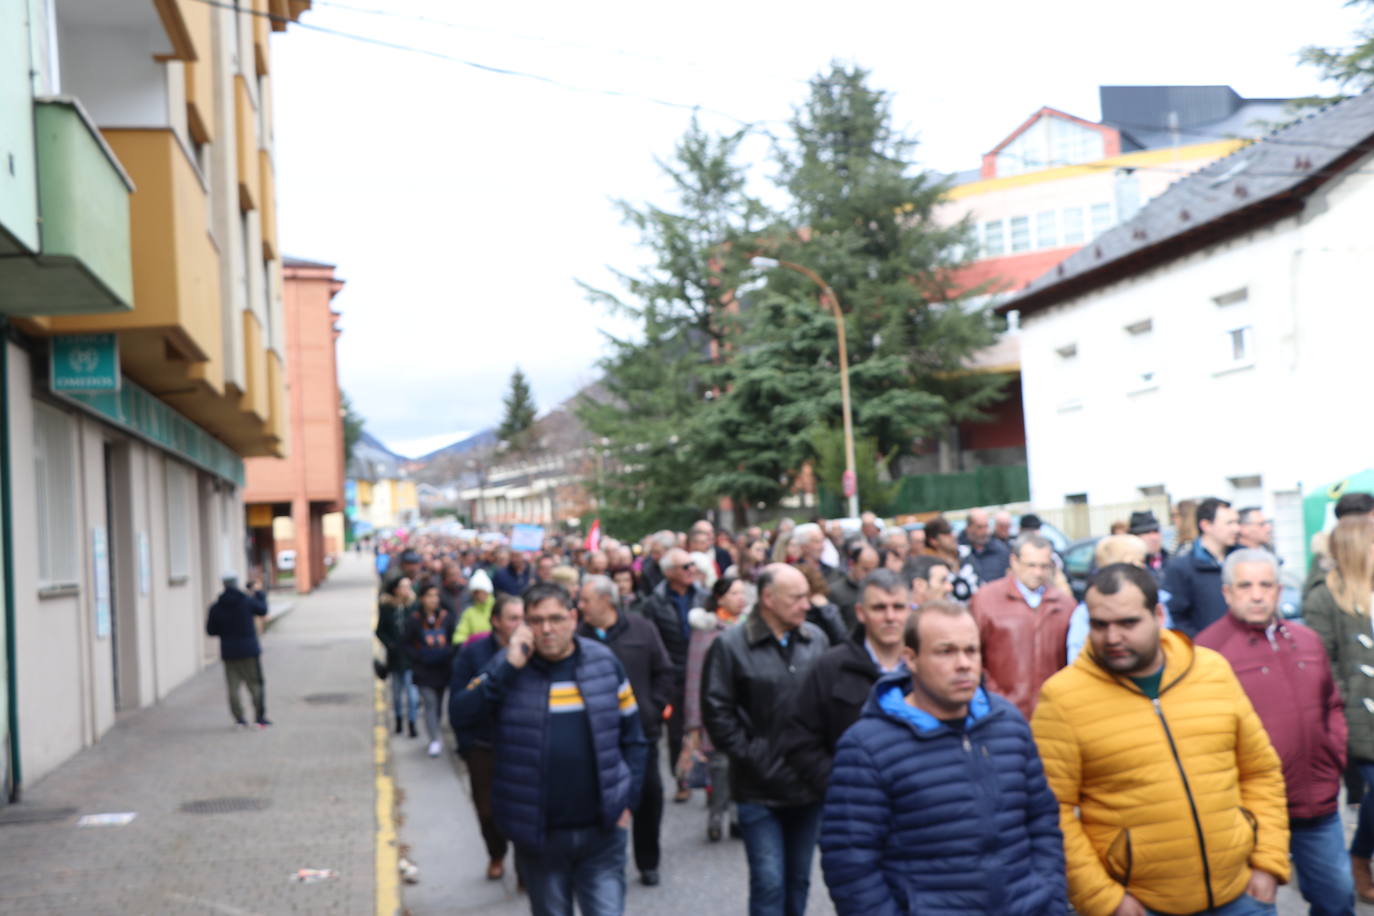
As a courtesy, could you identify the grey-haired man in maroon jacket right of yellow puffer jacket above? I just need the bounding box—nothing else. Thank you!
[1197,548,1355,913]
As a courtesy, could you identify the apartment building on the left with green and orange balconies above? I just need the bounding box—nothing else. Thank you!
[0,0,311,798]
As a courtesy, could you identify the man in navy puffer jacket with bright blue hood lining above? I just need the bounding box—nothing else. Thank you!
[820,600,1069,916]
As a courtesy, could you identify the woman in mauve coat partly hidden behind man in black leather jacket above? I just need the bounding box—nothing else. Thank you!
[676,575,746,842]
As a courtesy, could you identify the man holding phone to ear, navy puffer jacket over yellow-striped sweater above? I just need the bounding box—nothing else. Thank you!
[449,582,647,916]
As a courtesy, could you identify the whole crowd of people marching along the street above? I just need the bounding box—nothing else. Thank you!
[359,493,1374,916]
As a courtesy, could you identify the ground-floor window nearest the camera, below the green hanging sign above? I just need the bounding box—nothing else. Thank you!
[33,404,81,588]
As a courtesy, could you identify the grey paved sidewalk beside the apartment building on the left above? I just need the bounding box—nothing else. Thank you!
[0,555,378,916]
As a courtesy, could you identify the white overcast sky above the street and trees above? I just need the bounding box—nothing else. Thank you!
[272,0,1359,455]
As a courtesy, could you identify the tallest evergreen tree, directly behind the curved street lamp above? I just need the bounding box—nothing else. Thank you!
[699,65,1006,501]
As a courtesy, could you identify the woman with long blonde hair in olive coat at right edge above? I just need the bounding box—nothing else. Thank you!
[1303,515,1374,904]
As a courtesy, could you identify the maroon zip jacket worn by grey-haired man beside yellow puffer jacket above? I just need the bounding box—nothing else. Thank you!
[1195,614,1345,817]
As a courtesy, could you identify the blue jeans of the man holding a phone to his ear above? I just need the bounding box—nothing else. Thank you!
[515,827,625,916]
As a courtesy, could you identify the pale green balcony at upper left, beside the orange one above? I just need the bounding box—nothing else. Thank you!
[0,98,135,317]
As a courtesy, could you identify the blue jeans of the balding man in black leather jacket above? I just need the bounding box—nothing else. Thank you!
[739,802,820,916]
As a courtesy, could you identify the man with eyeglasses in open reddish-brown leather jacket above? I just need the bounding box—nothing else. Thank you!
[969,534,1074,720]
